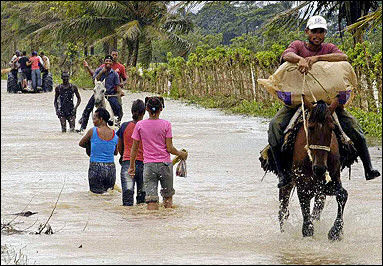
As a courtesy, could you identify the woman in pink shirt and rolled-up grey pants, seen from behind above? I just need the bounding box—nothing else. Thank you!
[128,97,188,210]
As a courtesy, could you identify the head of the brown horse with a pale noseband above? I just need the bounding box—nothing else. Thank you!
[305,94,338,177]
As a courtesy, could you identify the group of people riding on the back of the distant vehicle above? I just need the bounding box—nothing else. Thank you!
[9,50,50,91]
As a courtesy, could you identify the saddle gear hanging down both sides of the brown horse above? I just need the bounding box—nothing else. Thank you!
[259,108,358,175]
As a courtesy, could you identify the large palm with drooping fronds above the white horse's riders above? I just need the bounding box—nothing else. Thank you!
[59,1,192,66]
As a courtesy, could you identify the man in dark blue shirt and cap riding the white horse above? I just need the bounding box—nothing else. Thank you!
[79,55,122,132]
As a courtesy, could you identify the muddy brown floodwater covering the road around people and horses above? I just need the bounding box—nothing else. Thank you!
[1,81,382,264]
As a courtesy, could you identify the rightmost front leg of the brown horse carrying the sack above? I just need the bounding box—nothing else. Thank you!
[328,186,348,240]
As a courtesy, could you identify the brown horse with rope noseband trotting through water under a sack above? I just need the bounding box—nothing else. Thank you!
[279,98,348,240]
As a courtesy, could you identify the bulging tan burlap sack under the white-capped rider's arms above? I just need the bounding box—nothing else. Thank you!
[257,61,357,107]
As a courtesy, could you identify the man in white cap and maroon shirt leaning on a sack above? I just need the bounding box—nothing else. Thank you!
[268,16,380,188]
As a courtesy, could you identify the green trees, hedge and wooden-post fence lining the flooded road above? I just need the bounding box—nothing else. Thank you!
[1,1,382,137]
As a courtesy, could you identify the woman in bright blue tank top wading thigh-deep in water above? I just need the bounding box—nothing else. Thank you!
[79,108,118,194]
